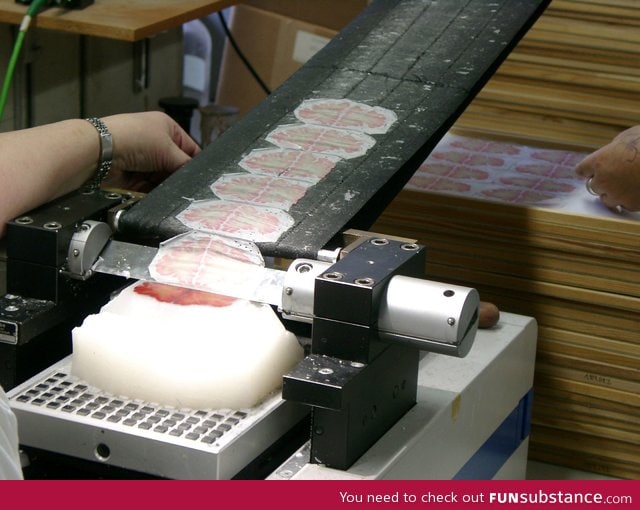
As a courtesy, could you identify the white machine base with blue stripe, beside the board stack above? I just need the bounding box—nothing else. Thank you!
[269,313,537,480]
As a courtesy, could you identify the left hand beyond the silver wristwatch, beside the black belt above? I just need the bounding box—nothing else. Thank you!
[102,111,200,192]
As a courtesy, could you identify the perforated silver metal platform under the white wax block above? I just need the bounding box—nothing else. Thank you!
[8,358,307,479]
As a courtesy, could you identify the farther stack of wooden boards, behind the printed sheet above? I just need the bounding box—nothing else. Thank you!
[457,0,640,148]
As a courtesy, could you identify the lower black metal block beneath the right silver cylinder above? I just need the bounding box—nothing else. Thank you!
[282,346,419,469]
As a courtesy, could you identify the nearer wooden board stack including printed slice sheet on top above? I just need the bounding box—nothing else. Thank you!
[373,130,640,478]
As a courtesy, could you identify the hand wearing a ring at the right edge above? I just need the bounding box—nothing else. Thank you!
[576,126,640,211]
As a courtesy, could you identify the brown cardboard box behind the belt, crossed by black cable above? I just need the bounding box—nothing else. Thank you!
[216,5,337,116]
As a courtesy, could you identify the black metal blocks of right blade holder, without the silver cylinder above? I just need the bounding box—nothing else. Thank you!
[282,237,425,469]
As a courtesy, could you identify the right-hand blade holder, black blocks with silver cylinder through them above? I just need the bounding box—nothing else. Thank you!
[282,238,479,469]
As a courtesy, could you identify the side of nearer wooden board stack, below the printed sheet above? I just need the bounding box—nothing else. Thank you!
[374,186,640,478]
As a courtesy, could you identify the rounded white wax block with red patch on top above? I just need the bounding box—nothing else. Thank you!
[71,283,303,409]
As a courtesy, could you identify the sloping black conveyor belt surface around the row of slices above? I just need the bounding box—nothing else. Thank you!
[119,0,549,258]
